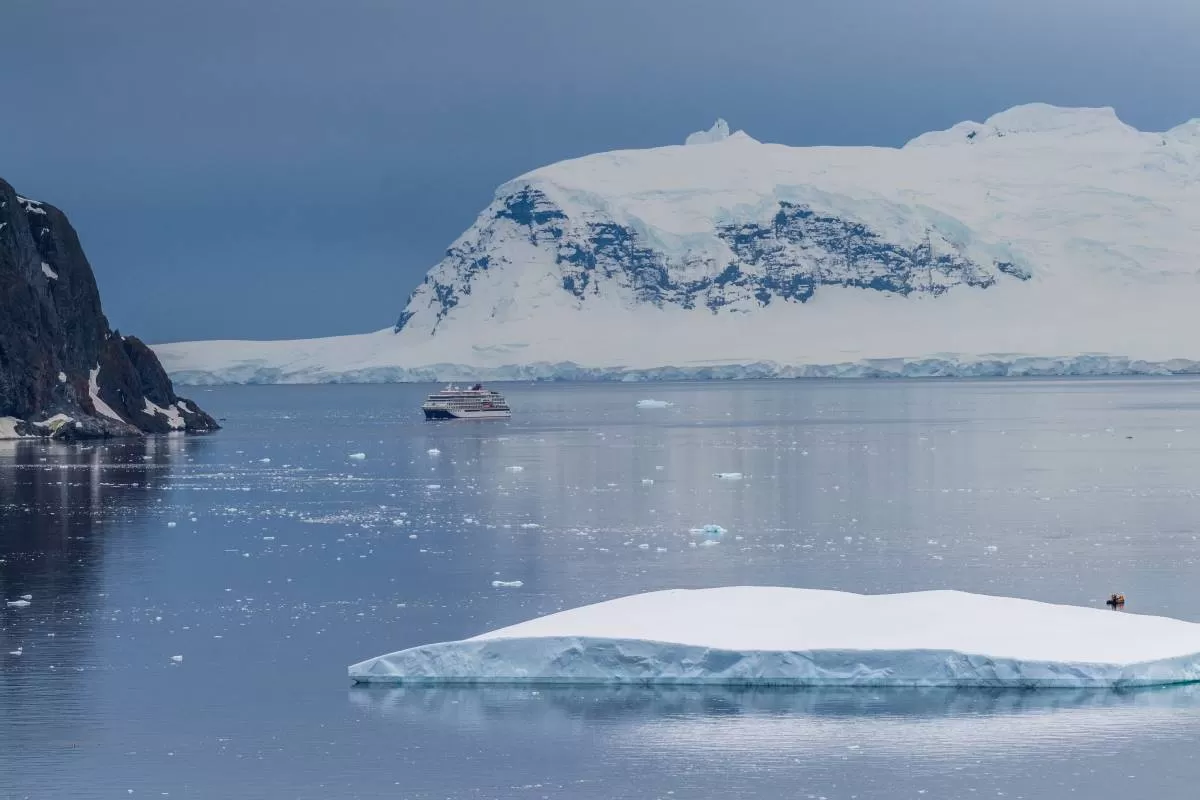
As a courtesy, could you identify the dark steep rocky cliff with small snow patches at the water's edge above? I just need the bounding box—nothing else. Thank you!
[0,180,218,439]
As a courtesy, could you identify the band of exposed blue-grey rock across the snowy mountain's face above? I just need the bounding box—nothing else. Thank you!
[395,186,1031,332]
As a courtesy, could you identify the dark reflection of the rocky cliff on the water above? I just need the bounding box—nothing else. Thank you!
[0,437,193,746]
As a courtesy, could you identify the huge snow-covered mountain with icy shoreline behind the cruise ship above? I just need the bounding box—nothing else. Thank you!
[157,104,1200,383]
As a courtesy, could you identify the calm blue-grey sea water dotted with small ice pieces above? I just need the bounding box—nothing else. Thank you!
[7,379,1200,800]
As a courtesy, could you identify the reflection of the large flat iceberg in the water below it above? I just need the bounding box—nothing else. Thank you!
[349,686,1200,752]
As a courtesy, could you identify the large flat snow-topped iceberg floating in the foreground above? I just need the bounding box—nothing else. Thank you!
[349,587,1200,688]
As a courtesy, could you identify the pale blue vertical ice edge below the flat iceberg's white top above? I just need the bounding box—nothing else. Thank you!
[349,637,1200,688]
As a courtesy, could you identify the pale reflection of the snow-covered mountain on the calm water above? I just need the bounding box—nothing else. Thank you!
[405,381,1200,606]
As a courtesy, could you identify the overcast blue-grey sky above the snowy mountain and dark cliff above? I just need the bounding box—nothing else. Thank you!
[0,0,1200,343]
